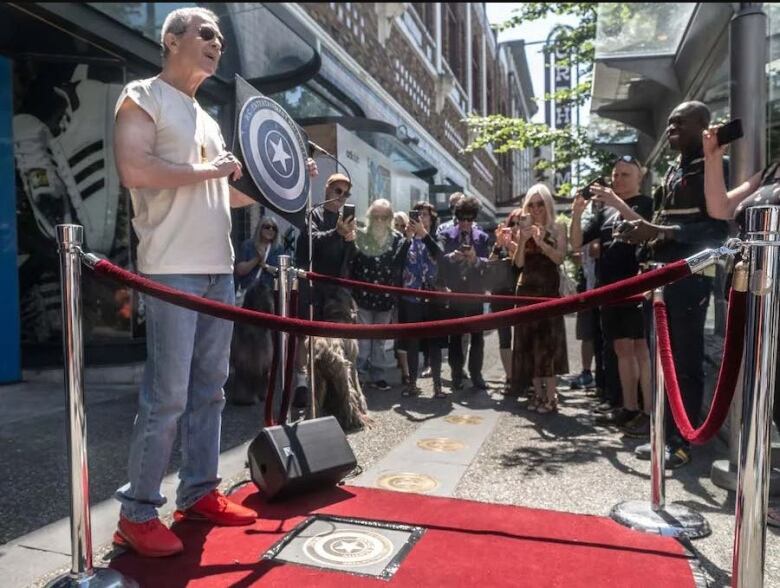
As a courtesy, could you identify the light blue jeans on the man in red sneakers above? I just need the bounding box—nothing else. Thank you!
[116,274,235,523]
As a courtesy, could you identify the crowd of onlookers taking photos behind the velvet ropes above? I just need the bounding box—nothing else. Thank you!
[237,102,748,476]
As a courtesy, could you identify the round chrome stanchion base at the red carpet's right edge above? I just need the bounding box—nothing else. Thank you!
[609,500,712,539]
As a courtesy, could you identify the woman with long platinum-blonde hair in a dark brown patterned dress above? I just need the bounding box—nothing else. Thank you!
[512,184,569,413]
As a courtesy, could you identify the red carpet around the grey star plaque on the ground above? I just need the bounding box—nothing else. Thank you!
[111,484,695,588]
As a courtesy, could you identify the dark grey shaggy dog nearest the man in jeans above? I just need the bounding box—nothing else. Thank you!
[225,280,274,406]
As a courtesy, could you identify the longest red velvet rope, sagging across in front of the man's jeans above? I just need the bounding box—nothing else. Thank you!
[88,259,691,339]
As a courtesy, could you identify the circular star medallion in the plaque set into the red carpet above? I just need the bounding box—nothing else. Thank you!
[303,529,393,567]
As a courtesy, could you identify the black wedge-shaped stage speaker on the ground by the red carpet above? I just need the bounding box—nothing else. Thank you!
[249,416,357,500]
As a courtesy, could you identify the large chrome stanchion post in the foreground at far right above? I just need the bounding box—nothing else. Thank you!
[731,206,780,588]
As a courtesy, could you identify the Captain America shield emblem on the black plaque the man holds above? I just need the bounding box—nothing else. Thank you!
[238,96,309,212]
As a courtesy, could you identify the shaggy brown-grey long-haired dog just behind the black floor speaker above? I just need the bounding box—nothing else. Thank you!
[312,292,374,431]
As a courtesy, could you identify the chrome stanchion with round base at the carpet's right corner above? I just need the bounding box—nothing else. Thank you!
[609,282,712,539]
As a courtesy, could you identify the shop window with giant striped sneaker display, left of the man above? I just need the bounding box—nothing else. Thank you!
[13,58,132,345]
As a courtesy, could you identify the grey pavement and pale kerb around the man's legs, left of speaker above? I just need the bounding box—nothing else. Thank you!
[0,365,263,588]
